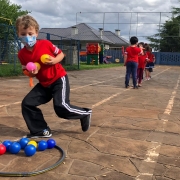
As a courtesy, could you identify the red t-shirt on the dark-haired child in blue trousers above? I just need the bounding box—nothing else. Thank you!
[125,46,141,63]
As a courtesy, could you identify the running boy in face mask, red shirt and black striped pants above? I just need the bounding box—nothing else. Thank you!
[16,15,92,137]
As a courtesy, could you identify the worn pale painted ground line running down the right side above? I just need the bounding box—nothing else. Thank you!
[136,73,180,180]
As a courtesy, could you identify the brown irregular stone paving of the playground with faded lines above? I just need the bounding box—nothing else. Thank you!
[0,66,180,180]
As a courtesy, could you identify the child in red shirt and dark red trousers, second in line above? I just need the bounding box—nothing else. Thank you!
[137,42,148,87]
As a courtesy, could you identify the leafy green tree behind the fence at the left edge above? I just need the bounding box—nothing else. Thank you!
[0,0,30,61]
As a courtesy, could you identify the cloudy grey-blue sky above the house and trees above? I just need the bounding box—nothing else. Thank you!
[10,0,180,39]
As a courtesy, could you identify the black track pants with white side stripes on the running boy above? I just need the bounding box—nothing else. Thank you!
[21,75,92,133]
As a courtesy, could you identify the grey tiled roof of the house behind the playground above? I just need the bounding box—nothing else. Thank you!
[38,23,129,46]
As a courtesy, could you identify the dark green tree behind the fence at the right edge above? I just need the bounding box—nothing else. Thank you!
[147,8,180,52]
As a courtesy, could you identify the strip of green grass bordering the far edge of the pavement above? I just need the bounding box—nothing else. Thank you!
[0,62,123,77]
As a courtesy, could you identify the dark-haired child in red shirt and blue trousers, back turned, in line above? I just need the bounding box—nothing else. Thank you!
[124,36,142,89]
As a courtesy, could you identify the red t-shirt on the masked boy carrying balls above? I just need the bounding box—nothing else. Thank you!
[18,40,66,87]
